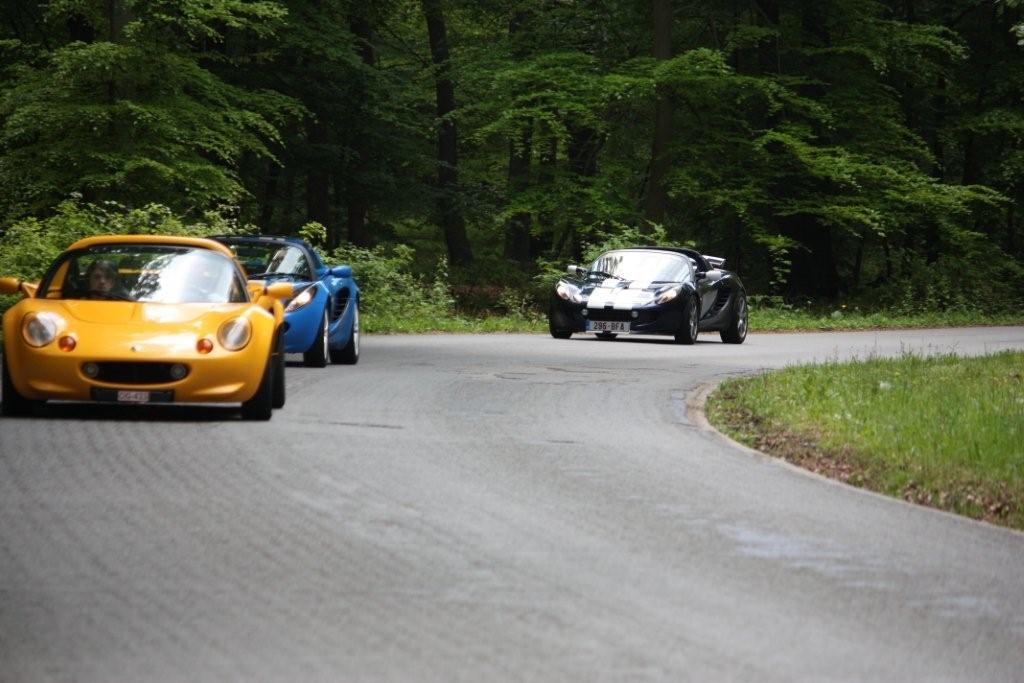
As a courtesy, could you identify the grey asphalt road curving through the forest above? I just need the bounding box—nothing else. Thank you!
[0,328,1024,682]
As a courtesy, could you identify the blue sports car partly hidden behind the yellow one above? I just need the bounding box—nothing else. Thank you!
[213,236,359,368]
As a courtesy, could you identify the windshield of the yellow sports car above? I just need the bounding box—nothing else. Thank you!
[37,244,249,303]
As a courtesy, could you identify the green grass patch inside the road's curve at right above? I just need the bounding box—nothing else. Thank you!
[708,352,1024,528]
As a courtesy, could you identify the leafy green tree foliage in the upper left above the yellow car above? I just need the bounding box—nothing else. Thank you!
[0,0,300,218]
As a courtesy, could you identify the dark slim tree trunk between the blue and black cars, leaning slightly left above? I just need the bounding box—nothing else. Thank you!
[422,0,473,265]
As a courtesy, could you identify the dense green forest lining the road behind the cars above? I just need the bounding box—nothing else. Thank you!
[0,0,1024,311]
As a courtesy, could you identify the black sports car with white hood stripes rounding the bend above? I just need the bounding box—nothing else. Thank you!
[548,247,746,344]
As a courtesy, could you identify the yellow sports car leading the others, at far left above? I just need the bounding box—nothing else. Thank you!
[0,236,292,420]
